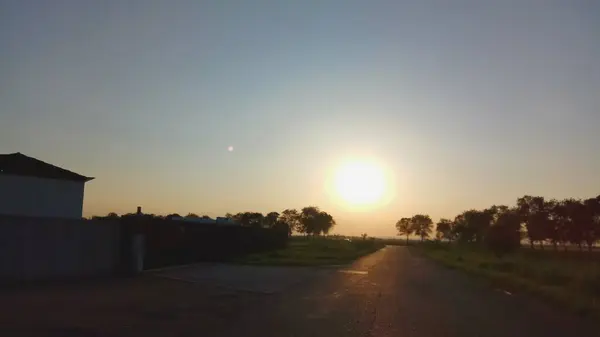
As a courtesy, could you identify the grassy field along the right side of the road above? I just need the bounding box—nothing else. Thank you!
[420,244,600,315]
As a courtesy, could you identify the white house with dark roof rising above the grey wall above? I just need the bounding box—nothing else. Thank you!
[0,152,94,218]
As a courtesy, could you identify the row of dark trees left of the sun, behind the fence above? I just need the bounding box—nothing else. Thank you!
[92,206,336,235]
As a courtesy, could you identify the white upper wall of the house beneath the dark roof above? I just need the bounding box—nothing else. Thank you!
[0,174,85,218]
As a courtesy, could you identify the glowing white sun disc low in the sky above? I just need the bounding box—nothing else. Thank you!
[334,161,387,206]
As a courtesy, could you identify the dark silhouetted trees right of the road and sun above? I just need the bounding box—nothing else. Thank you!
[396,195,600,252]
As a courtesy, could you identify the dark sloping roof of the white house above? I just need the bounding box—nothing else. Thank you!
[0,152,94,182]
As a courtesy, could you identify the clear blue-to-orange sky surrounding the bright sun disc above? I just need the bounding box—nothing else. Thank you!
[0,0,600,235]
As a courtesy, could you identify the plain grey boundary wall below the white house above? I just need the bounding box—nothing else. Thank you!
[0,215,121,283]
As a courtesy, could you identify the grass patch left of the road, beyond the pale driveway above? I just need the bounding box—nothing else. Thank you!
[233,237,384,266]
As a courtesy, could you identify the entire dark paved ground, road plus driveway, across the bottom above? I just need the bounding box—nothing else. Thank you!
[0,247,600,337]
